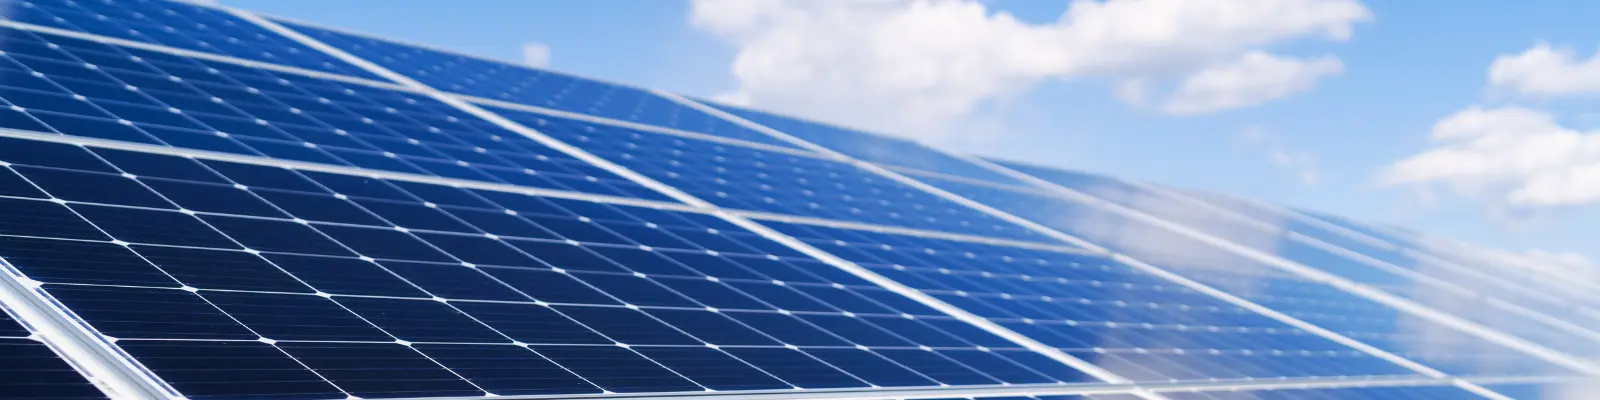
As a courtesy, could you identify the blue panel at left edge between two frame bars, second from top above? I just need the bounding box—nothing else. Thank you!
[0,29,666,200]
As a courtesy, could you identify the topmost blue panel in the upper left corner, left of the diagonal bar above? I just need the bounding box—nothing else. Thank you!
[0,0,379,80]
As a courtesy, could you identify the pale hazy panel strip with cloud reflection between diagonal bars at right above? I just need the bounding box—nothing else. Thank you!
[938,176,1571,374]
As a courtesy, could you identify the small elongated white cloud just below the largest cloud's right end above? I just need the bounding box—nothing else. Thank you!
[1163,51,1344,114]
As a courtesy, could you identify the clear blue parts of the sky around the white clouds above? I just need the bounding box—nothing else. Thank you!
[224,0,1600,265]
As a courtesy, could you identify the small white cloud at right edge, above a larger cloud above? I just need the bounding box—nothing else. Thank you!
[1490,43,1600,98]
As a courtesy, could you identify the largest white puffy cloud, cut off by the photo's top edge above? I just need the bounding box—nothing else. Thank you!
[690,0,1371,139]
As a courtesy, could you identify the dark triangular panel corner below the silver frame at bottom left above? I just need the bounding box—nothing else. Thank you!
[0,304,106,400]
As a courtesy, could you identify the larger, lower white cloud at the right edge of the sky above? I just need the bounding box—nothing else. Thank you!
[1381,107,1600,208]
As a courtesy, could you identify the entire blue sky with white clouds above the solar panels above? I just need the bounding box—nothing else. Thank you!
[224,0,1600,267]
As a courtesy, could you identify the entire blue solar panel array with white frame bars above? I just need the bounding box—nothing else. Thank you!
[0,0,1600,400]
